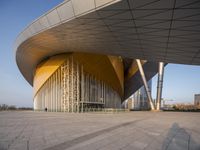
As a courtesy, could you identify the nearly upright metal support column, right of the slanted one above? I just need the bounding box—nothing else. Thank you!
[156,62,164,110]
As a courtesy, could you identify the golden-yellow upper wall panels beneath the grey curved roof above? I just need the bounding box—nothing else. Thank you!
[33,53,124,97]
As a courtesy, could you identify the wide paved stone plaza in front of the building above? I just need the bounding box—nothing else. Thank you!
[0,111,200,150]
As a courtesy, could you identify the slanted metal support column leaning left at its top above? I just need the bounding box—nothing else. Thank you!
[136,59,155,110]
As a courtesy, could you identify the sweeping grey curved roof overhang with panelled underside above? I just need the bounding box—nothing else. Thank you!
[15,0,200,88]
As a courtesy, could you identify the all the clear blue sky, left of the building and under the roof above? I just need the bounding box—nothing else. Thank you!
[0,0,200,106]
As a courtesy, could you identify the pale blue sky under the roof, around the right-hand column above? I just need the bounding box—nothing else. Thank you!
[152,64,200,103]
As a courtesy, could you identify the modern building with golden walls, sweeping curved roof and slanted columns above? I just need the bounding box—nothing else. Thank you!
[15,0,200,112]
